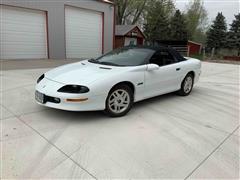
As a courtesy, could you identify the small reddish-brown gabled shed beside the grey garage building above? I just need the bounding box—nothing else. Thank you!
[114,25,145,48]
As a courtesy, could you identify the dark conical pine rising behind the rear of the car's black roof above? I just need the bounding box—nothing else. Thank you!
[170,10,188,41]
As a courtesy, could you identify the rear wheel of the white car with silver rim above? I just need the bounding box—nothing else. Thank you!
[177,73,194,96]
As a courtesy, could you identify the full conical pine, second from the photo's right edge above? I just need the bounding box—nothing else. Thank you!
[207,13,227,50]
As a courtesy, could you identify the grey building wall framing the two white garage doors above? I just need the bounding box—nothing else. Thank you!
[0,0,114,59]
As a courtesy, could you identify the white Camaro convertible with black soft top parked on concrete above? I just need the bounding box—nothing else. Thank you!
[35,47,201,117]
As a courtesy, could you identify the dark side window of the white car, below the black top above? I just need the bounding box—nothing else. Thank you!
[150,49,175,66]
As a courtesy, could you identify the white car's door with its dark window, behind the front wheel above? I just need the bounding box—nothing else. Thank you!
[145,49,182,98]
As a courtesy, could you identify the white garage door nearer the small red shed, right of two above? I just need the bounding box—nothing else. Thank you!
[65,7,102,58]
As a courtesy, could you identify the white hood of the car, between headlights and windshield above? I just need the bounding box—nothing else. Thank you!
[45,60,124,85]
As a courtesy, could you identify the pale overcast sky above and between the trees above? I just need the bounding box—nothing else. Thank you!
[175,0,240,25]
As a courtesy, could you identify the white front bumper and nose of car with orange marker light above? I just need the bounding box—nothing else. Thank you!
[35,78,106,111]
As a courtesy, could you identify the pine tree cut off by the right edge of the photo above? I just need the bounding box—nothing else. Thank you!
[227,13,240,56]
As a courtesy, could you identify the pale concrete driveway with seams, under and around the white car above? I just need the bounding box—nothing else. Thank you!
[0,63,240,179]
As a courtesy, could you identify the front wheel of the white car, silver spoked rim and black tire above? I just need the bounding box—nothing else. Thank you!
[104,84,133,117]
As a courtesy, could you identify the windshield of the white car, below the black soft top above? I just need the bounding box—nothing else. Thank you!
[89,48,154,66]
